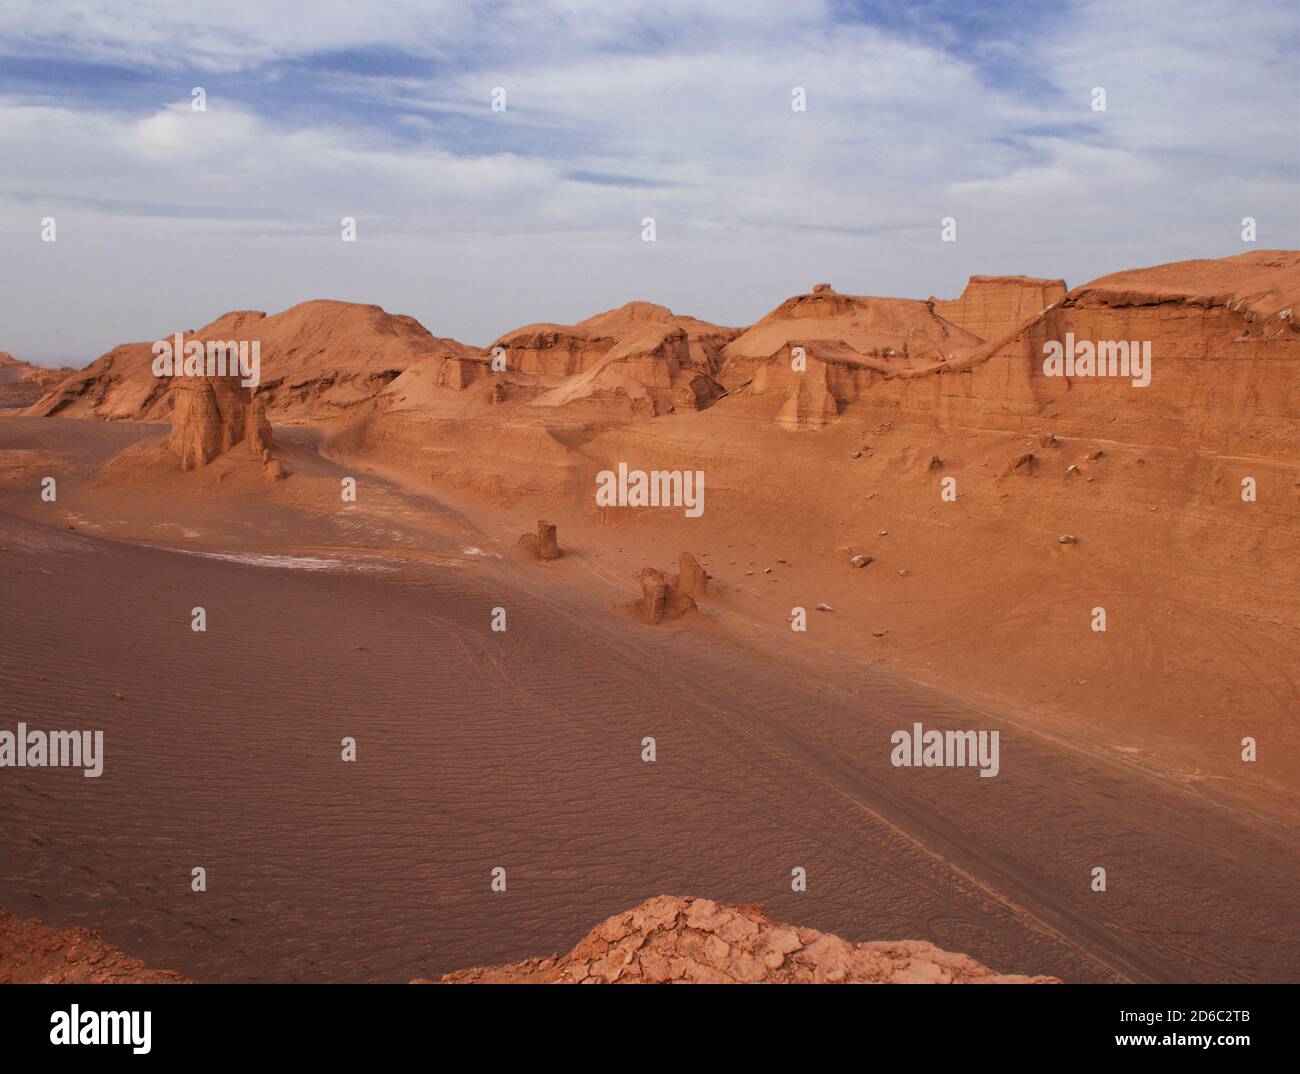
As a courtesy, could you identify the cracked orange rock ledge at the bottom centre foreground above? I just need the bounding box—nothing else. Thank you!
[412,895,1061,984]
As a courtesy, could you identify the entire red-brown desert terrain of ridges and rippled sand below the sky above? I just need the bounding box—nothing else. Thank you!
[0,250,1300,982]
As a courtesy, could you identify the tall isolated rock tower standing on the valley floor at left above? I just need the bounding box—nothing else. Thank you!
[168,376,272,471]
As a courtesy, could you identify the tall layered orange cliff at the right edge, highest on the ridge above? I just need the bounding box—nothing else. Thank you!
[866,251,1300,462]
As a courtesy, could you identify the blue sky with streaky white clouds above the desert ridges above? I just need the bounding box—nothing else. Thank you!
[0,0,1300,365]
